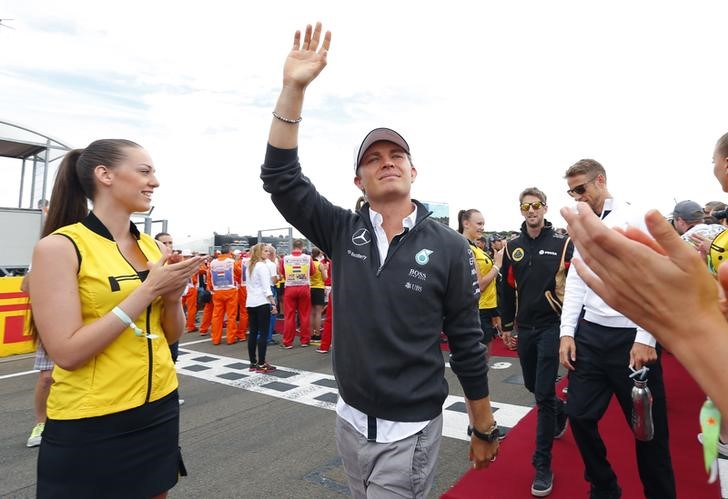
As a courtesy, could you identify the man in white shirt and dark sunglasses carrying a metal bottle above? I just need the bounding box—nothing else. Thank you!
[559,159,675,499]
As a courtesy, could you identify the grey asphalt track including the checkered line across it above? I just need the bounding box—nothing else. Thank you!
[0,333,534,499]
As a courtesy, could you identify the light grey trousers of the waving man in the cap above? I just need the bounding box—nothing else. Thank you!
[336,414,442,499]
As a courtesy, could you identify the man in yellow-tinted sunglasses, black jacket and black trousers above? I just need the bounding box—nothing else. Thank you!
[501,187,574,497]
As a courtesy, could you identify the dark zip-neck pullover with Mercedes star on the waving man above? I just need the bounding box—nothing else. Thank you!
[261,145,488,421]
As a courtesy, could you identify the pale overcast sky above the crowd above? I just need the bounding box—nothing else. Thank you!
[0,0,728,241]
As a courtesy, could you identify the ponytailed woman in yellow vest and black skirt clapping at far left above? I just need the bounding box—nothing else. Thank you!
[30,140,200,498]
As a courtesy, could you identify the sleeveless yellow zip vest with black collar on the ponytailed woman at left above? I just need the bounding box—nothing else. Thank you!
[48,212,177,419]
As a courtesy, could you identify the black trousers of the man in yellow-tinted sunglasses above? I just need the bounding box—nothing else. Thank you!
[518,324,564,468]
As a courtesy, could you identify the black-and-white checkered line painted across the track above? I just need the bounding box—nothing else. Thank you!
[177,348,531,440]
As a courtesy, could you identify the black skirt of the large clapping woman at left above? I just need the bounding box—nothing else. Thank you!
[37,390,184,499]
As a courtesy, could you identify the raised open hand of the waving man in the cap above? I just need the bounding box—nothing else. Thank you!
[283,23,331,89]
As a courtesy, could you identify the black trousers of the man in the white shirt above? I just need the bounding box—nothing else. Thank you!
[566,319,675,499]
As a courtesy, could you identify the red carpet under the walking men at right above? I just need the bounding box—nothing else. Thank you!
[442,353,720,499]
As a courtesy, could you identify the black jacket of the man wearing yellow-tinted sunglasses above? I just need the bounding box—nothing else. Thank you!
[499,221,574,331]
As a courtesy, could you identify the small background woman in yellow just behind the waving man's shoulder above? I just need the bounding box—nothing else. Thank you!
[458,209,503,355]
